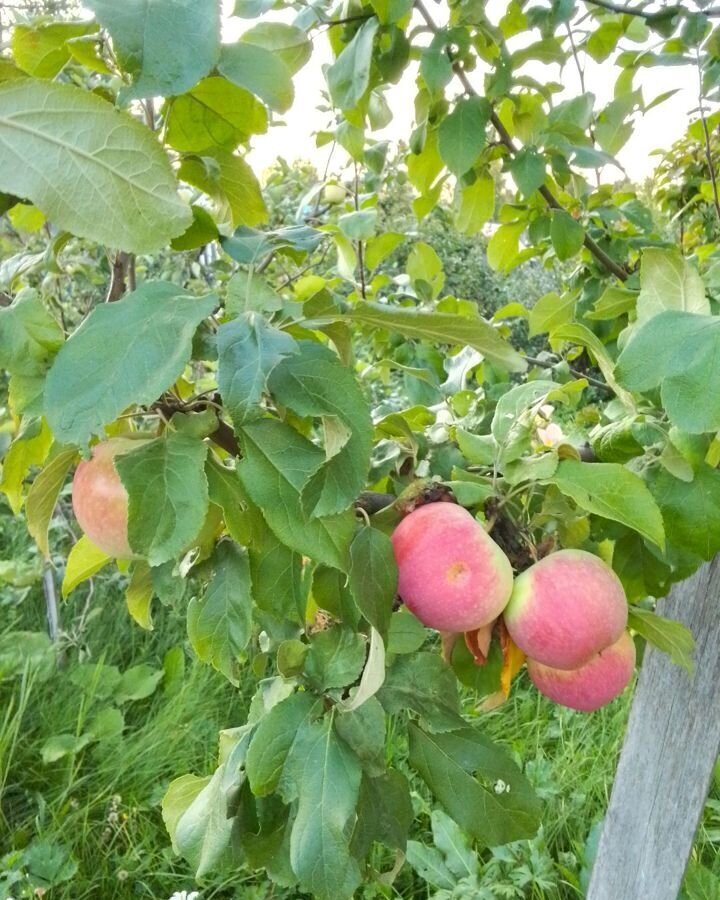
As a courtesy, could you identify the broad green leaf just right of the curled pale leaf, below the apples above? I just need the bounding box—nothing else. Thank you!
[377,653,463,731]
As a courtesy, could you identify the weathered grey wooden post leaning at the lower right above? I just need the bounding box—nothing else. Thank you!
[587,555,720,900]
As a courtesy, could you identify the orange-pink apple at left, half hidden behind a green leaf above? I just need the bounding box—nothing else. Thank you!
[72,438,140,559]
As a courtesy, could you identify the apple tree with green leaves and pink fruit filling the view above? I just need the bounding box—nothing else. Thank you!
[0,0,720,900]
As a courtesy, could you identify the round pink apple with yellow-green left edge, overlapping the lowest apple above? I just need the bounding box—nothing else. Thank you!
[504,550,628,669]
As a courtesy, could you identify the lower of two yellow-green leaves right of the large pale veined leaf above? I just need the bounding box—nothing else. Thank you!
[178,149,267,226]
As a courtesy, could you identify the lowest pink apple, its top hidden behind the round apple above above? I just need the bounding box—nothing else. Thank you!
[527,631,635,712]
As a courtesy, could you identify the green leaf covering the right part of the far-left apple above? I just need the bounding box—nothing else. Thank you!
[115,432,208,566]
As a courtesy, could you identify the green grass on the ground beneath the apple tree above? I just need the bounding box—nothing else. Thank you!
[0,500,720,900]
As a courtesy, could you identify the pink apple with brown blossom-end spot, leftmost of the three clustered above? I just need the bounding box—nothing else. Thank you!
[392,503,512,632]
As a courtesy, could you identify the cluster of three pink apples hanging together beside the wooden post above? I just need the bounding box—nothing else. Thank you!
[392,503,635,712]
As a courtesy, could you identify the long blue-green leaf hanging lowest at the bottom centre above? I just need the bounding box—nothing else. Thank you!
[290,717,361,900]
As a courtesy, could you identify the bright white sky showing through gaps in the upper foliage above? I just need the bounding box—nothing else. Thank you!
[233,0,698,181]
